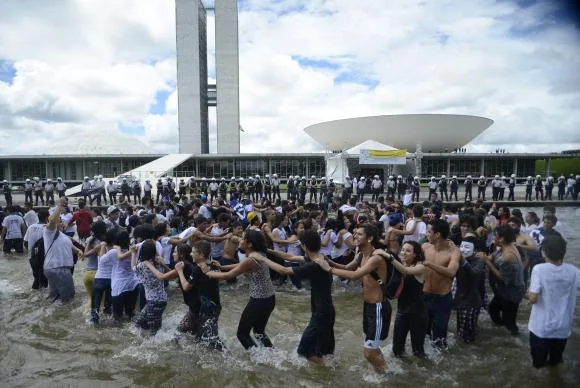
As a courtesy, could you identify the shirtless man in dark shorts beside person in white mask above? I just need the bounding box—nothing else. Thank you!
[423,219,461,349]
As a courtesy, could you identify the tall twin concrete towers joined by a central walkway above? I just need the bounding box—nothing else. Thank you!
[175,0,240,154]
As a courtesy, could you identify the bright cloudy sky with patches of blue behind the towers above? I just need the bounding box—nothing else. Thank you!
[0,0,580,154]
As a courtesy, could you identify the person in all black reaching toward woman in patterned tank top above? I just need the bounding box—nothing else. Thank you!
[252,230,335,363]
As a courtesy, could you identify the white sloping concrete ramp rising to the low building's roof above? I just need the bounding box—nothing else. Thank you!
[65,154,192,197]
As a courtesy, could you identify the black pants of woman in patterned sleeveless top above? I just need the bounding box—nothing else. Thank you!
[237,295,276,349]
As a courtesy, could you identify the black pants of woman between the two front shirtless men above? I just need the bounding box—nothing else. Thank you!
[393,303,427,357]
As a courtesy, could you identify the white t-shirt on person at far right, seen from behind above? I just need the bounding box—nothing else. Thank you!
[528,263,580,338]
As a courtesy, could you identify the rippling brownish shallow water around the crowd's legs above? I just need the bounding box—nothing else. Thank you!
[0,208,580,387]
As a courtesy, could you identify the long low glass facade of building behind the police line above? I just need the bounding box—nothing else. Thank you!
[0,155,545,182]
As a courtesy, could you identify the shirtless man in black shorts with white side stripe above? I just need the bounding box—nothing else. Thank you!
[320,224,391,371]
